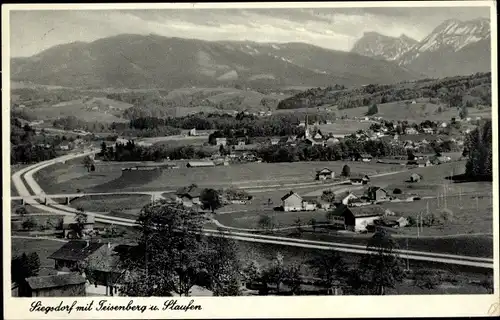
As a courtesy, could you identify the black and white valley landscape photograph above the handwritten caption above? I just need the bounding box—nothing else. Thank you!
[2,1,498,316]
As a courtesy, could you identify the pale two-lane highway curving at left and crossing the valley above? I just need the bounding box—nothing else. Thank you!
[12,151,493,268]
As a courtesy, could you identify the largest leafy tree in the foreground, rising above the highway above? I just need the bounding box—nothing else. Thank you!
[120,200,207,297]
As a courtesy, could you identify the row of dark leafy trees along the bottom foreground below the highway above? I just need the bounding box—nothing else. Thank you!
[116,201,405,296]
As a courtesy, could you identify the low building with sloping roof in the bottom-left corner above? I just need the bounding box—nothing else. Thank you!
[19,272,86,297]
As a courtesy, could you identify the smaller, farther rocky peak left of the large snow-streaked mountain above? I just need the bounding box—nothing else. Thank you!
[351,32,418,61]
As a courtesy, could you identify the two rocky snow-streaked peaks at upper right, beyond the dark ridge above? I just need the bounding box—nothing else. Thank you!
[352,19,491,77]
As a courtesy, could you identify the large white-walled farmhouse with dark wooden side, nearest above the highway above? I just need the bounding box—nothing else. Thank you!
[332,204,385,232]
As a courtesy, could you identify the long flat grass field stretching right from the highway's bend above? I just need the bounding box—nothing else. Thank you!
[35,161,400,193]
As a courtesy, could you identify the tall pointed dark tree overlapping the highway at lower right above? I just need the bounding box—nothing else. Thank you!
[357,229,404,295]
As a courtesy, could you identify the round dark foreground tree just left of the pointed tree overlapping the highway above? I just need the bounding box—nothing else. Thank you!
[308,251,348,296]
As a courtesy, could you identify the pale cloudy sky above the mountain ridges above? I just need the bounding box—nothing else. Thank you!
[10,7,489,57]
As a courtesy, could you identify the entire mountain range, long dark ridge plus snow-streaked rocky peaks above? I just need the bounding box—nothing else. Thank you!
[11,19,491,89]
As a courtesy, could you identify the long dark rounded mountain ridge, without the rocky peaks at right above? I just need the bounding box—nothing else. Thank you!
[11,34,423,89]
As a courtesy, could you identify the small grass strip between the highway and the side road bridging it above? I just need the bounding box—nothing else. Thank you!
[70,194,151,212]
